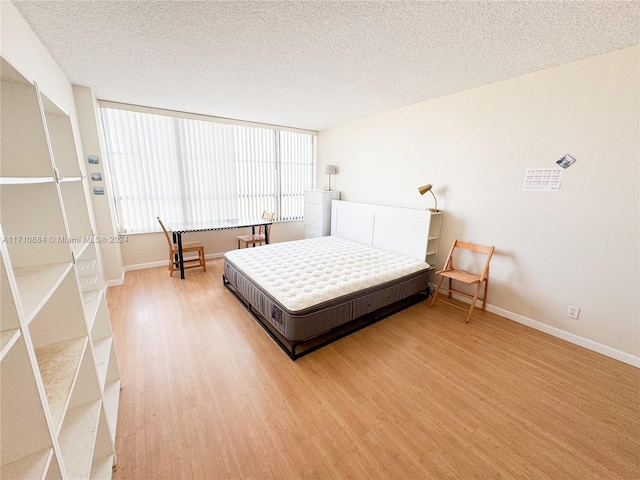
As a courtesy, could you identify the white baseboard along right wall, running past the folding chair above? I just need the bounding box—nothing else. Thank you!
[429,284,640,368]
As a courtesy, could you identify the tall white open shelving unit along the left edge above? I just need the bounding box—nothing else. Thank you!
[0,59,120,480]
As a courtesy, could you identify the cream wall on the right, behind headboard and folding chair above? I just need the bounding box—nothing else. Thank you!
[317,47,640,365]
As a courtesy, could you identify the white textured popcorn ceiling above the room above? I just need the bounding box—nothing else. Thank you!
[13,0,640,130]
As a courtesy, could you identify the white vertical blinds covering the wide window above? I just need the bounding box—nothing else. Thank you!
[100,106,316,233]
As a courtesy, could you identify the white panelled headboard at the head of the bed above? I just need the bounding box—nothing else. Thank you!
[331,200,431,261]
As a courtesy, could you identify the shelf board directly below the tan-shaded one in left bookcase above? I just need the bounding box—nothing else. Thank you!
[59,400,100,479]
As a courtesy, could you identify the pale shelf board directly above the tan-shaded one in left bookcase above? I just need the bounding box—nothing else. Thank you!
[14,262,72,323]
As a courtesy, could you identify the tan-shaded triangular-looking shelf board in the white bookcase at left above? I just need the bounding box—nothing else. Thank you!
[36,337,87,431]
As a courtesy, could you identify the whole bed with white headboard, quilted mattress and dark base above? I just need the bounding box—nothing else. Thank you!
[223,201,431,360]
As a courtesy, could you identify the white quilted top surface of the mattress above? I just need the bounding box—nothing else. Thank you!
[225,237,430,312]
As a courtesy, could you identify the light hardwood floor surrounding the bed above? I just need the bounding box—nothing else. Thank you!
[108,259,640,480]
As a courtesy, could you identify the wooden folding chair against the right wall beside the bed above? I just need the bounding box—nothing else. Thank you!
[431,240,495,323]
